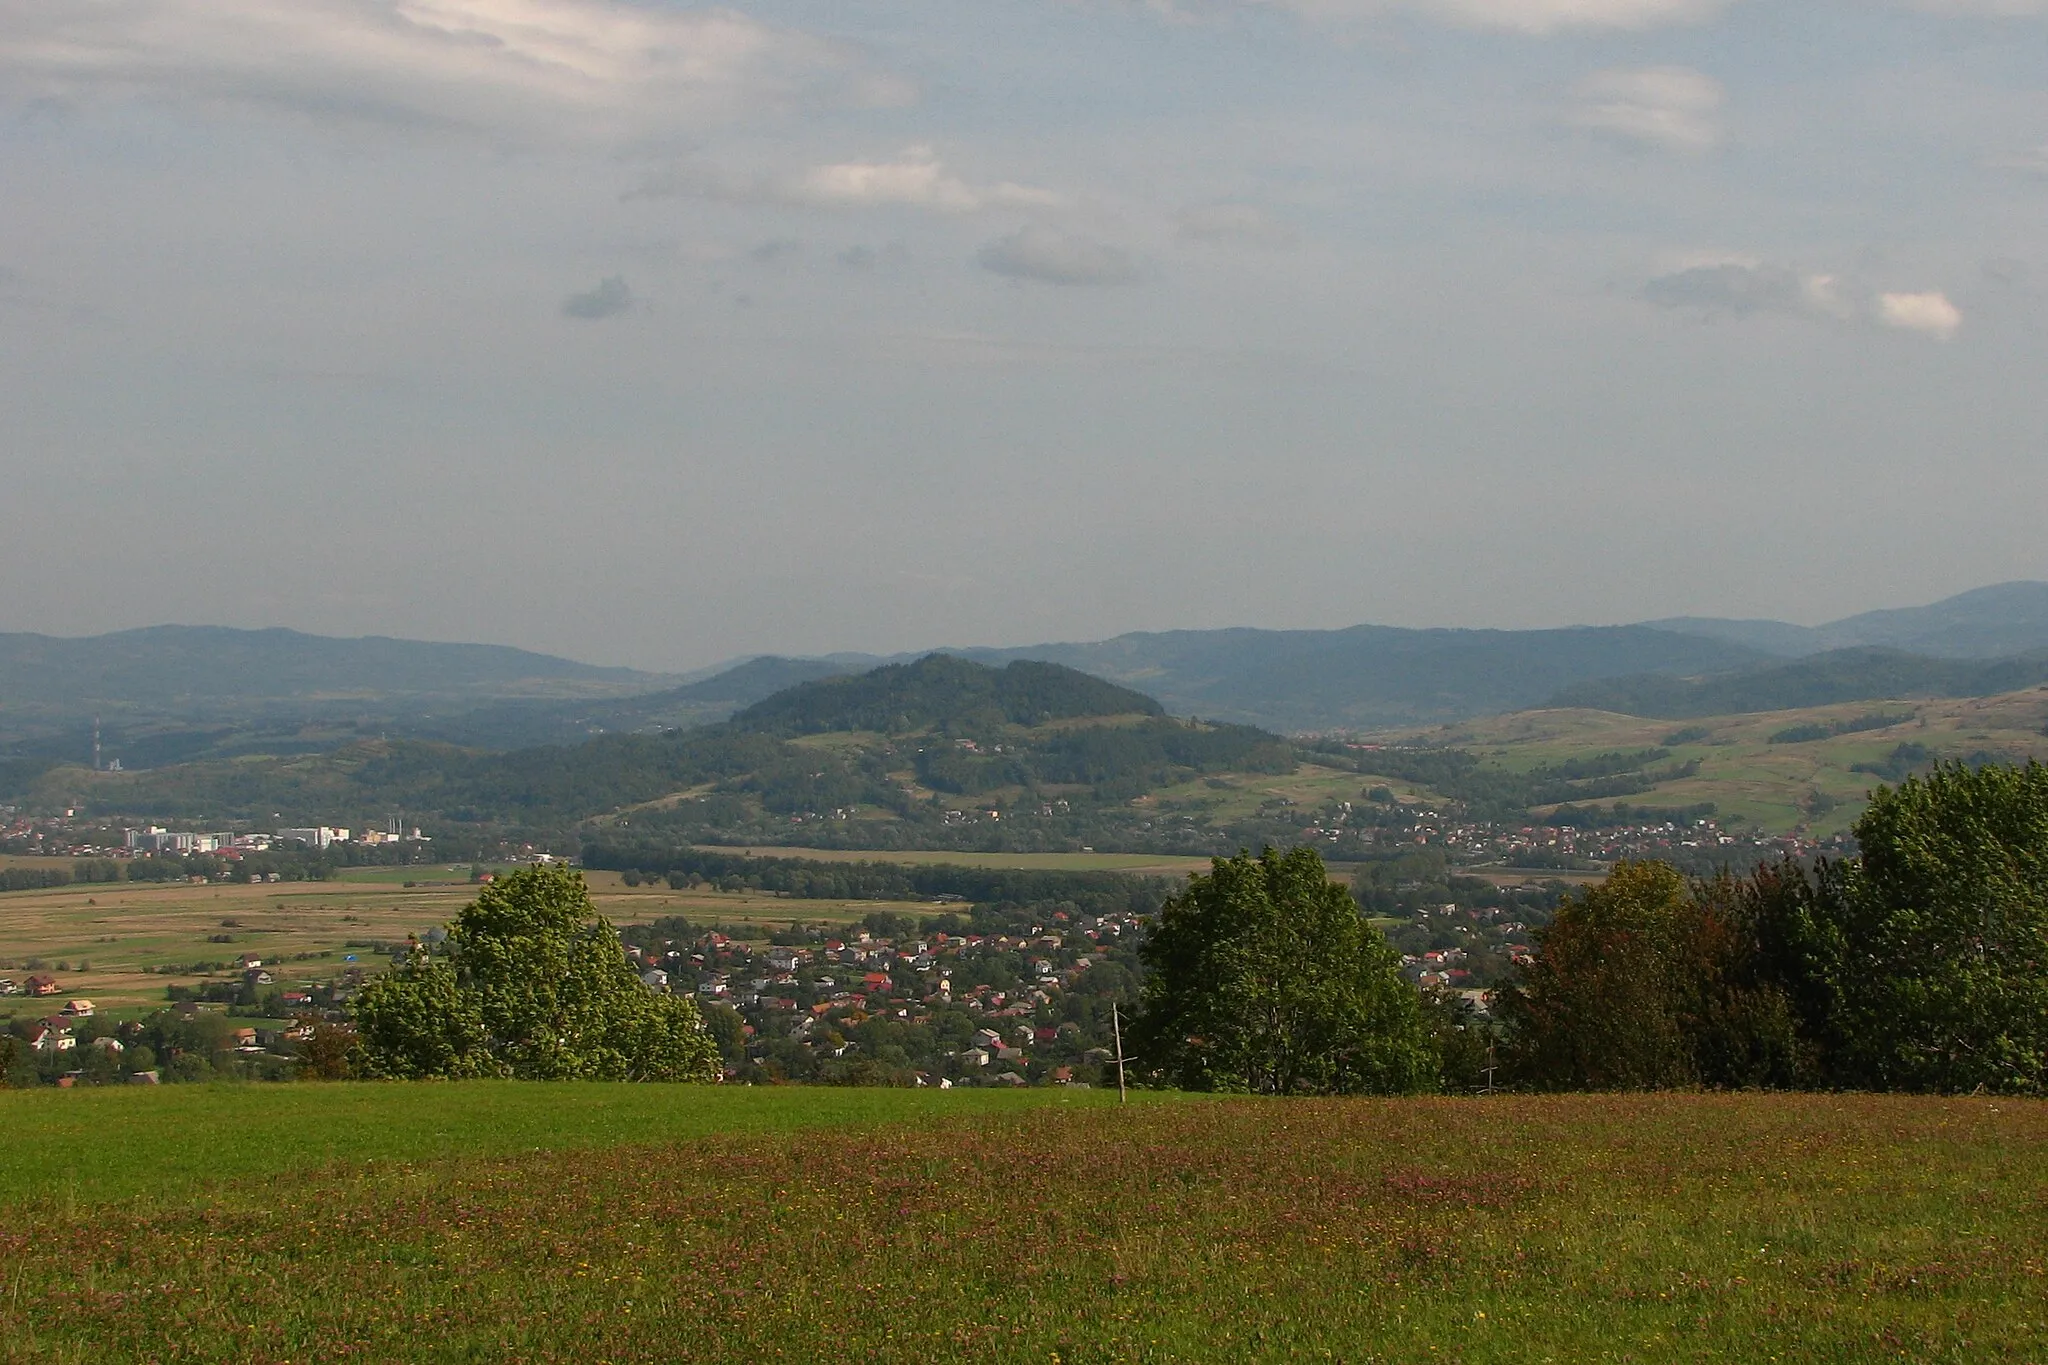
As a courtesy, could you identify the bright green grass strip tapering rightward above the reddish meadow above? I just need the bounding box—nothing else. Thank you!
[0,1081,1114,1209]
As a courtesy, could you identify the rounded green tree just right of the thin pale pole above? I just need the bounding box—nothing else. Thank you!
[1133,847,1436,1095]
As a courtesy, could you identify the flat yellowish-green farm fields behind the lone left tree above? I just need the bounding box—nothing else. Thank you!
[0,864,903,1021]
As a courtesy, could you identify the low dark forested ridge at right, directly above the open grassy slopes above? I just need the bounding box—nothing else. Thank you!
[1548,649,2048,720]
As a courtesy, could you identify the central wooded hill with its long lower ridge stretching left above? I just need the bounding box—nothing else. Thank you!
[19,657,1298,847]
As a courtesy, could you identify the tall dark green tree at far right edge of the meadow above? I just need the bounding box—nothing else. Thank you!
[1827,763,2048,1093]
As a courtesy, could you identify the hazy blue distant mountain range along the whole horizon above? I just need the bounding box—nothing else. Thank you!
[12,583,2048,761]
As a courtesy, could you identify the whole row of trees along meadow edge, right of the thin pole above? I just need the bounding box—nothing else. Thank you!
[1135,763,2048,1093]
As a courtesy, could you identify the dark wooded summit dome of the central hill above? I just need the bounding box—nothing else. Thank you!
[733,655,1165,735]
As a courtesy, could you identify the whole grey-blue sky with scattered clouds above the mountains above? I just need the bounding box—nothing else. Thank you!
[0,0,2048,669]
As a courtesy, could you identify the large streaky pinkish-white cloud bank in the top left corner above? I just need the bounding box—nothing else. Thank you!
[0,0,909,141]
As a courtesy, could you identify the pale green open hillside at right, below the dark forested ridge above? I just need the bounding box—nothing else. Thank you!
[1368,688,2048,835]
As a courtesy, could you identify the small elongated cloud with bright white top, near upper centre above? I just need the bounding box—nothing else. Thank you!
[647,147,1065,213]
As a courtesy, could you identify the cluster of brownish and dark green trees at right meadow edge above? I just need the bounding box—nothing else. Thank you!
[1499,763,2048,1093]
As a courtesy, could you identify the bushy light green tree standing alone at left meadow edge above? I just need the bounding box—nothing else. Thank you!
[354,866,719,1081]
